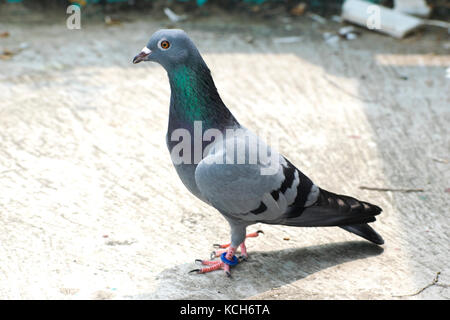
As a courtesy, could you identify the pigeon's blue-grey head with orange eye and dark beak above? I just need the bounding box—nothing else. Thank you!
[133,29,200,71]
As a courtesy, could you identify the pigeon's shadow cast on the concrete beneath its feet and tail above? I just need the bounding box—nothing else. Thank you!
[127,241,384,299]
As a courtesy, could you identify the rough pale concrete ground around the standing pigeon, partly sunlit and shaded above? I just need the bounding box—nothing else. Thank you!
[0,5,450,299]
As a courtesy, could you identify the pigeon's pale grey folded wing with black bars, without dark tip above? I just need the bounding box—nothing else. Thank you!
[195,132,318,223]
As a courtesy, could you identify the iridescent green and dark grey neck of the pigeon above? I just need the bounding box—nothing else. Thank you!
[168,63,235,128]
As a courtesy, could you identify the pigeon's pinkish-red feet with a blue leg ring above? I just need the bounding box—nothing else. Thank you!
[189,230,264,277]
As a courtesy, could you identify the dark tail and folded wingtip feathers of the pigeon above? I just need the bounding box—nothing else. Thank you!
[283,189,384,244]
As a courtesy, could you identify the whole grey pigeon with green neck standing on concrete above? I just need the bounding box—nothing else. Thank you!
[133,29,384,276]
